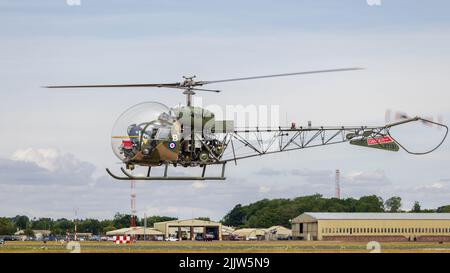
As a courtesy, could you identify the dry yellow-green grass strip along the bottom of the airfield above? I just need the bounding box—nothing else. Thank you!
[0,241,450,253]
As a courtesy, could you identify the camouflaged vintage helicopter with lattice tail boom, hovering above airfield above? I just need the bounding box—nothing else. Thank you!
[45,67,448,180]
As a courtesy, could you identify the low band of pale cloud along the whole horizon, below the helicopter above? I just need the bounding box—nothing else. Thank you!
[0,149,450,220]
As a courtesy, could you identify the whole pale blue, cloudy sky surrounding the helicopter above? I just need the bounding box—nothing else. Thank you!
[0,0,450,220]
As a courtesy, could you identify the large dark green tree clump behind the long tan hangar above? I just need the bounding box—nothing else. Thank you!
[222,194,450,228]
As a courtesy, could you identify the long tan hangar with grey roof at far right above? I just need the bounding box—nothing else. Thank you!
[291,212,450,242]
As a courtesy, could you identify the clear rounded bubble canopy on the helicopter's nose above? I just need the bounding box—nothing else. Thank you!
[111,102,175,161]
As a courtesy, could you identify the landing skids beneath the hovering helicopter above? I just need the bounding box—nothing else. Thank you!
[106,163,226,180]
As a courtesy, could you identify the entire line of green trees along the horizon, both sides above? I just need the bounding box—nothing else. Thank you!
[0,194,450,236]
